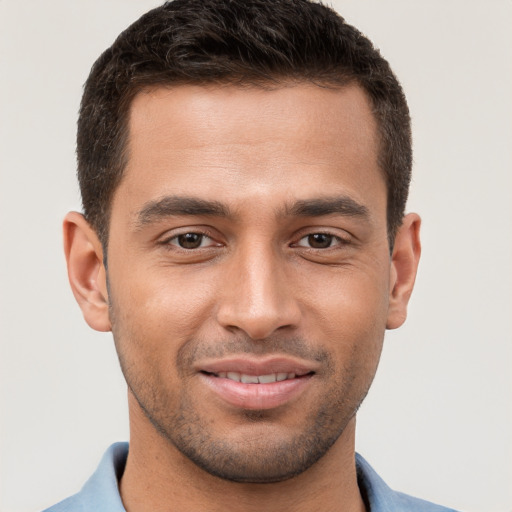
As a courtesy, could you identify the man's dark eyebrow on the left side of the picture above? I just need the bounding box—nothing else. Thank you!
[137,196,231,228]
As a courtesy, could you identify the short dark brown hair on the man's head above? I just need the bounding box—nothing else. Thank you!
[77,0,412,248]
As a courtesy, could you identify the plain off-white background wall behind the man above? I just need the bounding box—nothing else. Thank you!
[0,0,512,512]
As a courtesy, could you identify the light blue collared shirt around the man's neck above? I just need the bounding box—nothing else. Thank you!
[44,443,455,512]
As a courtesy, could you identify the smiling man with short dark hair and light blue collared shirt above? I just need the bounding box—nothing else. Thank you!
[45,0,456,512]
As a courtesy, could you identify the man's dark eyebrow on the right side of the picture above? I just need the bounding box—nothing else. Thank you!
[285,196,369,218]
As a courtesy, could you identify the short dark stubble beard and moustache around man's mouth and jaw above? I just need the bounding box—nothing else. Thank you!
[111,294,376,484]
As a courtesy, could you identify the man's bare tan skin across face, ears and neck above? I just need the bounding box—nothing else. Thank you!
[64,84,420,512]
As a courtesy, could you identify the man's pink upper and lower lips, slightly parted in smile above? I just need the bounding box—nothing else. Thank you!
[198,357,316,410]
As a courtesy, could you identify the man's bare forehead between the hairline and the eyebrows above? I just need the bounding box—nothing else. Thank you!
[114,84,385,218]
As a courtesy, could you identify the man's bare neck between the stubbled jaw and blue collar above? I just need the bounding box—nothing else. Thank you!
[119,394,365,512]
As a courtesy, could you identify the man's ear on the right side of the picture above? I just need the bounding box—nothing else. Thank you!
[386,213,421,329]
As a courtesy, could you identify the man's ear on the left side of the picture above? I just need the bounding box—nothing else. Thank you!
[63,212,111,331]
